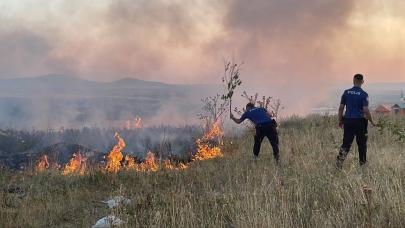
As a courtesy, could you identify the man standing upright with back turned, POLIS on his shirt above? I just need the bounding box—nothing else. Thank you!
[336,74,375,168]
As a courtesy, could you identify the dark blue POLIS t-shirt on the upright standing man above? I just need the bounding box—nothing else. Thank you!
[340,86,368,119]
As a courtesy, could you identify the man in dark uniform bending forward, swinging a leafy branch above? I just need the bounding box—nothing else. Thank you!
[231,103,280,164]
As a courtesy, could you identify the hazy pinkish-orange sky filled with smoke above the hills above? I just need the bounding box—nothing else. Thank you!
[0,0,405,111]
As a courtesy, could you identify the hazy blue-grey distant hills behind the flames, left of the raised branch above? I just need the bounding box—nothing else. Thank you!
[0,75,217,129]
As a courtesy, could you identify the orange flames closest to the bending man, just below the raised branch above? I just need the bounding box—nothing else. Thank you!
[193,122,223,161]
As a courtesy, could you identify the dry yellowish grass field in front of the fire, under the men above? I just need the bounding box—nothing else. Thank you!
[0,117,405,227]
